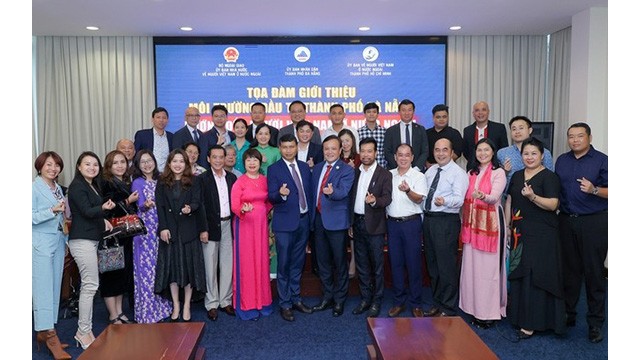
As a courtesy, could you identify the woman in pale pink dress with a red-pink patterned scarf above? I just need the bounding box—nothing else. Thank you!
[460,138,507,329]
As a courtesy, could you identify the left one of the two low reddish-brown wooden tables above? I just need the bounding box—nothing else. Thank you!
[78,322,204,360]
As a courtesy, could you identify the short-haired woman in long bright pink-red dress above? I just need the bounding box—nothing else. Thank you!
[231,148,273,320]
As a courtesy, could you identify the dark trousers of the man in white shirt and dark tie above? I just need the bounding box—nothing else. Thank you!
[422,213,460,315]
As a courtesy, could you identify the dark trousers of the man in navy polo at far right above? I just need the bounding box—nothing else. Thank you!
[560,213,609,327]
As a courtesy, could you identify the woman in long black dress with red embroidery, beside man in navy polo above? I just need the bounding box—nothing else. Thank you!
[506,138,566,339]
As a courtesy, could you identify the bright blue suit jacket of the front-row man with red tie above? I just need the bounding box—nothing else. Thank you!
[311,159,355,230]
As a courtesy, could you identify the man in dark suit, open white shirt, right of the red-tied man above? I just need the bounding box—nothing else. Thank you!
[351,137,392,317]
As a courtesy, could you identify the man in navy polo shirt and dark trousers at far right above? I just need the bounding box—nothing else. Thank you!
[556,123,609,343]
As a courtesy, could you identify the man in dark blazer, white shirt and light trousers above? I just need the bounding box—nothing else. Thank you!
[198,145,236,321]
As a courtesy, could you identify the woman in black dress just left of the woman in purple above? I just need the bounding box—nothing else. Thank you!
[100,150,138,324]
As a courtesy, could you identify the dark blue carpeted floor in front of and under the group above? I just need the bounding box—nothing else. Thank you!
[33,287,608,360]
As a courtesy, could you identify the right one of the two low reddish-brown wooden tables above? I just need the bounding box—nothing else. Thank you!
[367,316,498,360]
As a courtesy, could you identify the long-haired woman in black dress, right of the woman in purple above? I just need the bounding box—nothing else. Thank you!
[155,149,207,322]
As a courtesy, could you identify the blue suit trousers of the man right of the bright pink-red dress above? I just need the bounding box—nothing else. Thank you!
[275,214,309,309]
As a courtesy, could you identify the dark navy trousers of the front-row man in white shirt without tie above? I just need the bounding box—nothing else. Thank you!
[387,217,422,308]
